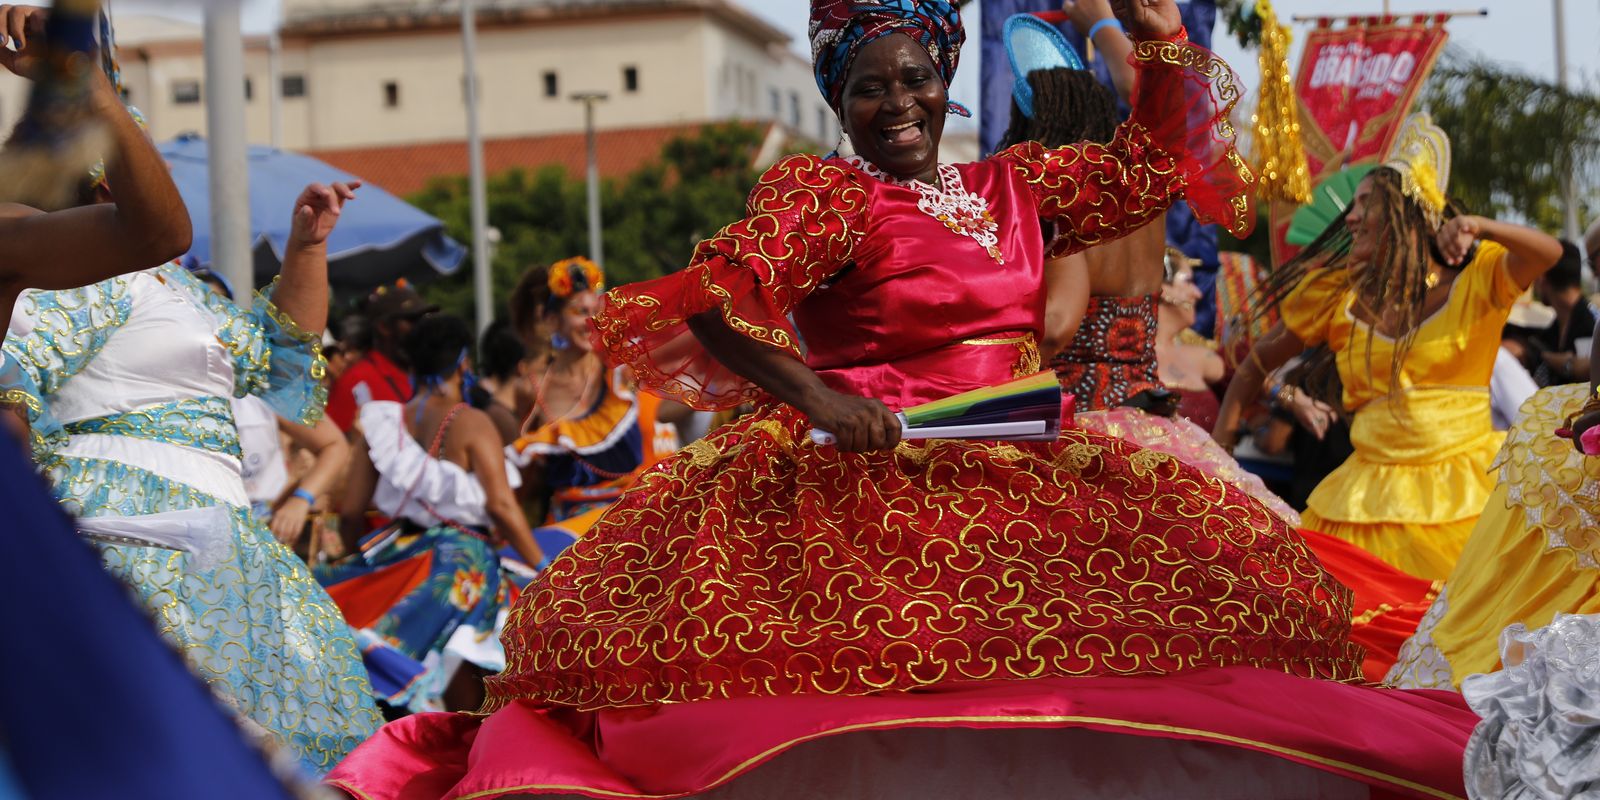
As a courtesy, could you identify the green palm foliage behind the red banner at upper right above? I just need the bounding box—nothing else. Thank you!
[1418,46,1600,230]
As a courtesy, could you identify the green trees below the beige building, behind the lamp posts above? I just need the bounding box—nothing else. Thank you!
[410,123,765,318]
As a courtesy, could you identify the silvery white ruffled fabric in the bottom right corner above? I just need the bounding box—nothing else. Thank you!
[1461,614,1600,800]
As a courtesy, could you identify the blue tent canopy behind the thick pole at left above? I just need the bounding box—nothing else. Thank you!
[160,134,467,293]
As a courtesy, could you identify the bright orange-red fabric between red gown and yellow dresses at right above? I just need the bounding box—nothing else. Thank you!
[1301,528,1438,683]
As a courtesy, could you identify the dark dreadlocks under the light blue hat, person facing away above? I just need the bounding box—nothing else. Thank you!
[1000,67,1117,149]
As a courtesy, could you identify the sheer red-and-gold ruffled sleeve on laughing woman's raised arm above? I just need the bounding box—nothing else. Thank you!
[995,37,1256,258]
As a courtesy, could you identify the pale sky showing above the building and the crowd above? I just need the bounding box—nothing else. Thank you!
[112,0,1600,120]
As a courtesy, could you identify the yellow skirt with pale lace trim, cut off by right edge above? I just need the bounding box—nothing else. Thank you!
[1386,384,1600,690]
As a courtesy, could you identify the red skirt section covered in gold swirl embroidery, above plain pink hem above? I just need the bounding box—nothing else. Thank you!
[483,408,1362,712]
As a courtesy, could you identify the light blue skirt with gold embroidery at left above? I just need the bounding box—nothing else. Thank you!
[46,456,382,778]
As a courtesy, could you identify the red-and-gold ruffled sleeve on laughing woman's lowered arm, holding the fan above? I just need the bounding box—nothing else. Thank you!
[592,155,867,410]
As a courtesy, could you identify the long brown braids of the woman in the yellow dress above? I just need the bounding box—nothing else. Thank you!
[1251,166,1466,408]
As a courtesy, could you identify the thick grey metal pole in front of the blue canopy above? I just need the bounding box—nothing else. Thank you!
[205,0,251,309]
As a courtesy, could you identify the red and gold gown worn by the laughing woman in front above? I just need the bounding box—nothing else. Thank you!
[331,42,1475,800]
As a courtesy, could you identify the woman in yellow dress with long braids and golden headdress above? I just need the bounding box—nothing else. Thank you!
[1213,114,1562,581]
